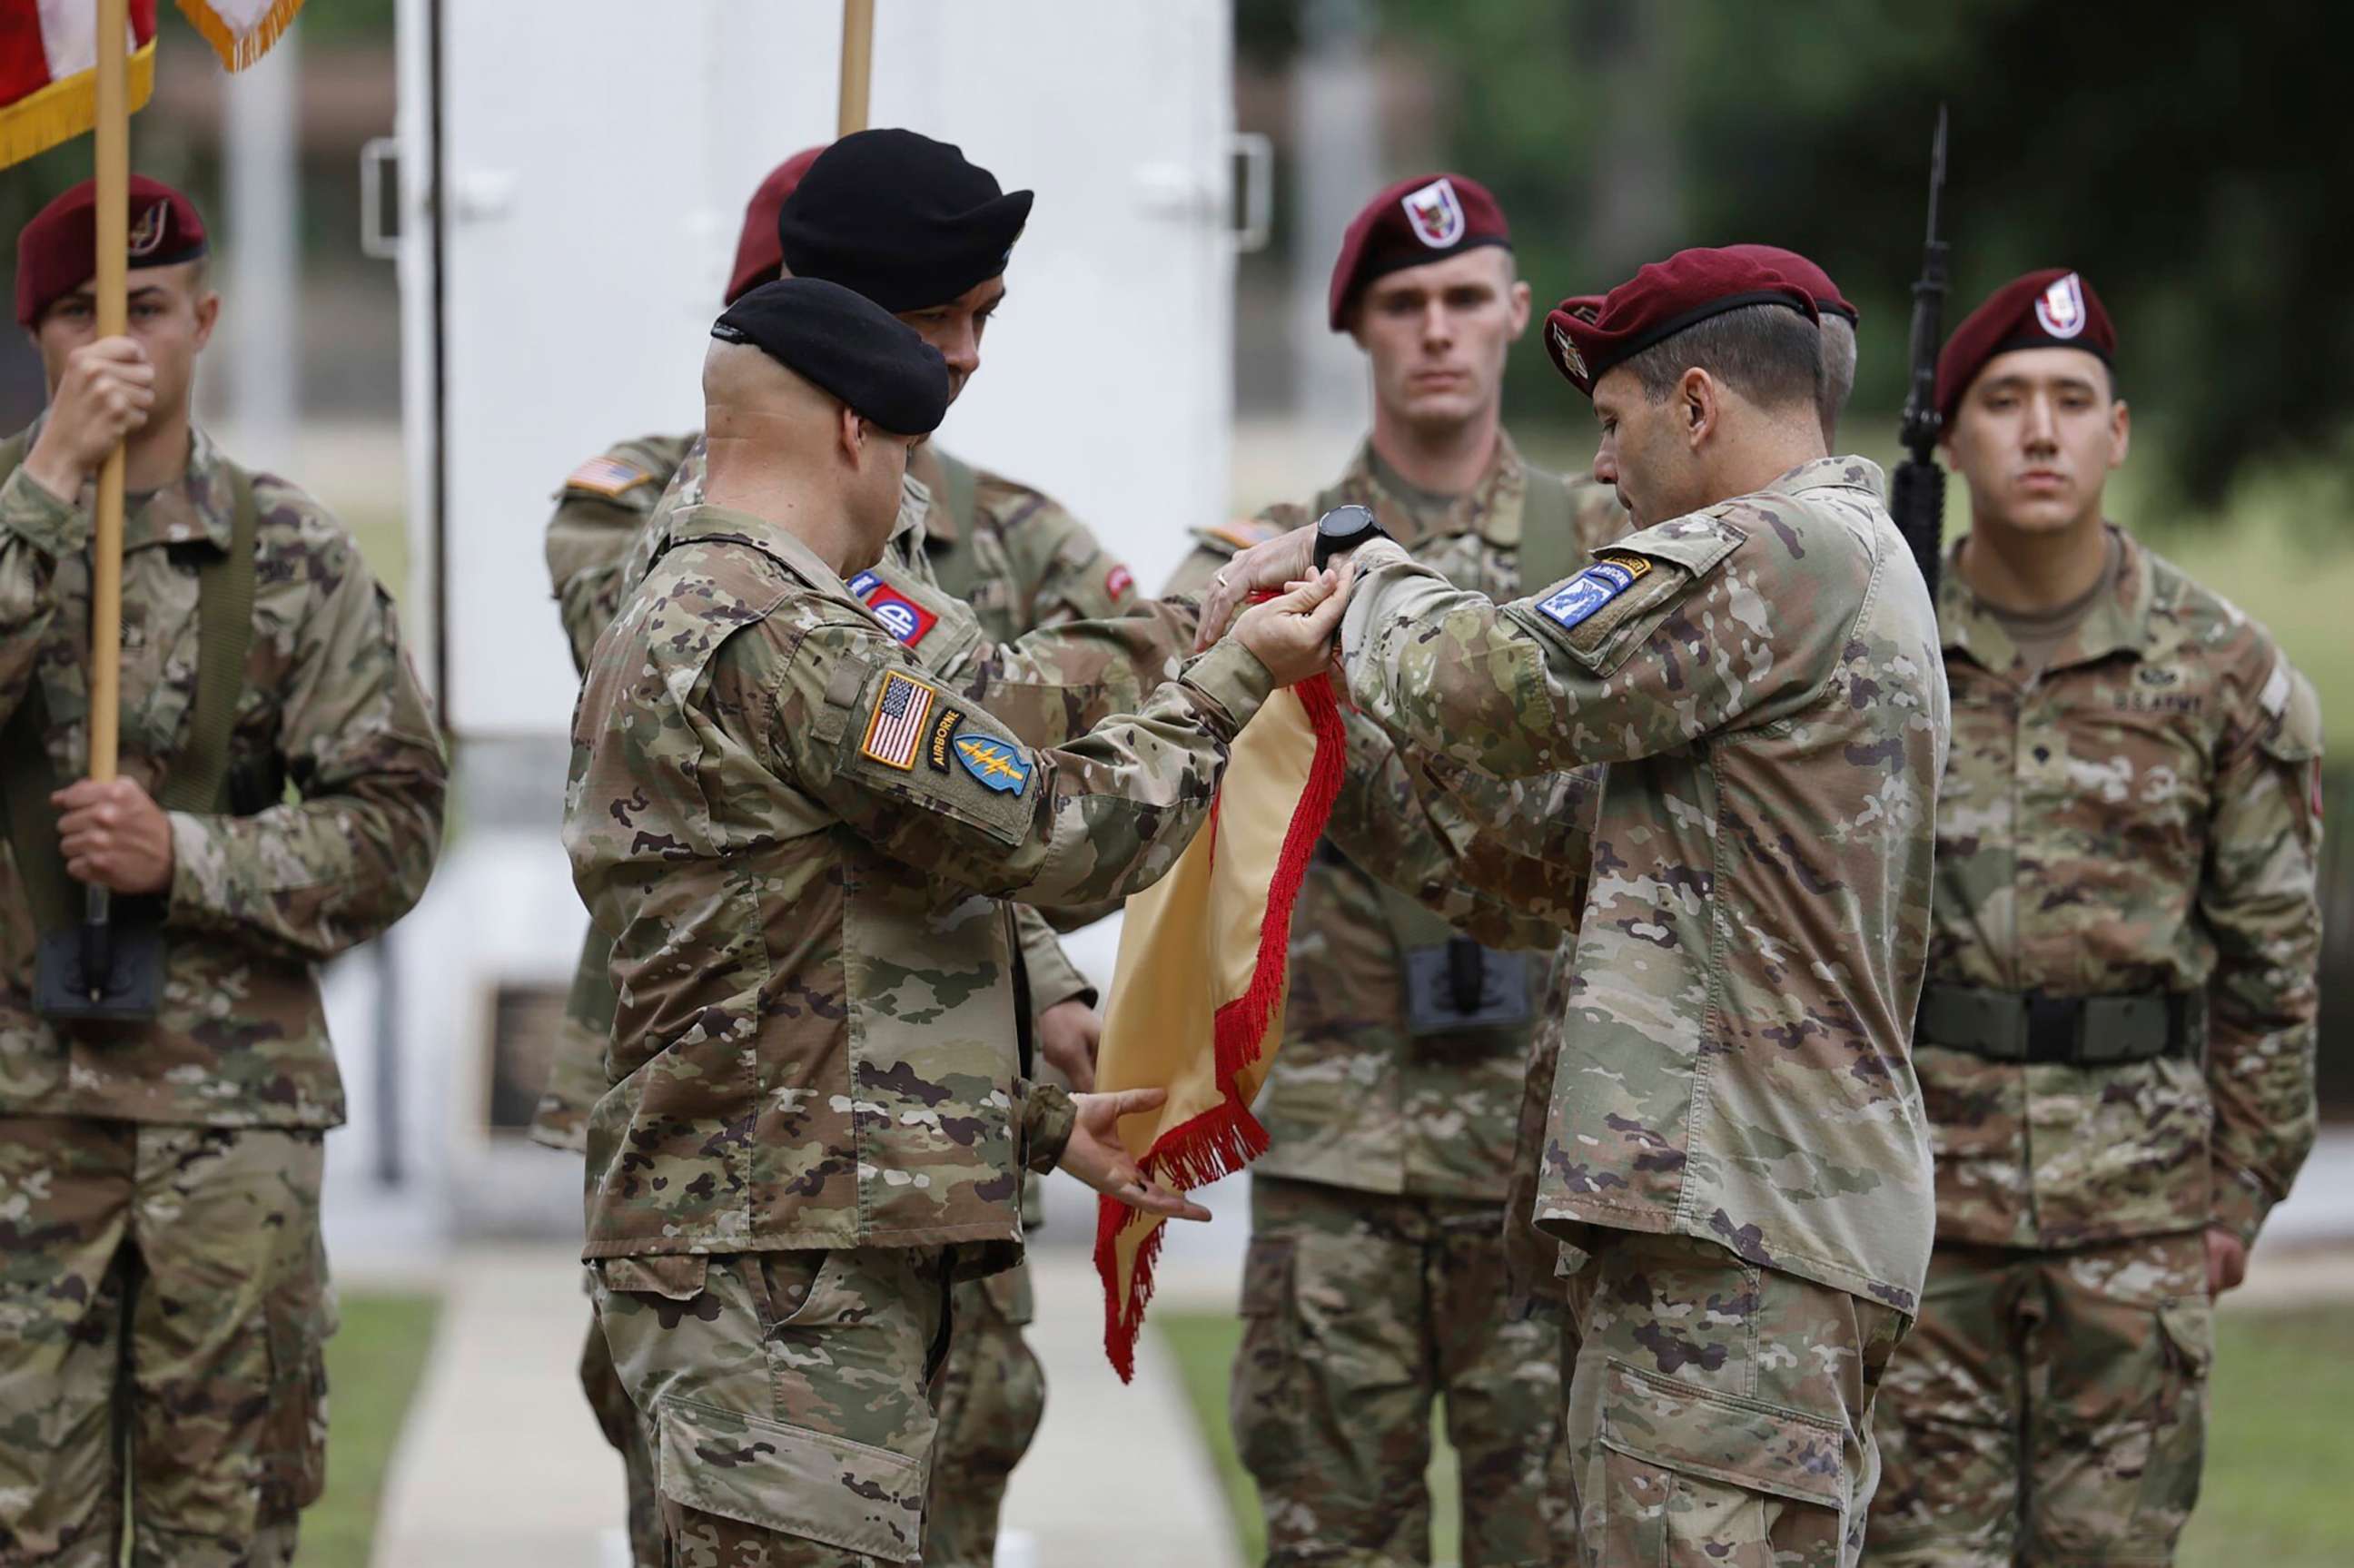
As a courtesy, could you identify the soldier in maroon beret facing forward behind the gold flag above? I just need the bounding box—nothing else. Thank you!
[1168,174,1624,1568]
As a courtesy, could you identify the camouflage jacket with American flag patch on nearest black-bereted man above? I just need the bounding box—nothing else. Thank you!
[565,507,1271,1271]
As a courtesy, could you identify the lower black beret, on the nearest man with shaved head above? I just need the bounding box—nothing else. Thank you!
[711,278,949,436]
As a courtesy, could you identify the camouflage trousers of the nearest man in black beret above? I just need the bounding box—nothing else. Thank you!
[593,1247,949,1568]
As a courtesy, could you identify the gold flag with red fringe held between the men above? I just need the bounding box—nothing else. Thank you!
[1094,676,1344,1380]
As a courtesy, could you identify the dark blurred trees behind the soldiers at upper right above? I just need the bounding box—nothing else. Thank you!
[1238,0,2354,523]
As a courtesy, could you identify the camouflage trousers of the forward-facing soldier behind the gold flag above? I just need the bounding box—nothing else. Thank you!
[1231,1178,1572,1568]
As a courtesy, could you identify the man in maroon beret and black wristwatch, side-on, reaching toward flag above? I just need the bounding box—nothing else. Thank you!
[1203,251,1947,1568]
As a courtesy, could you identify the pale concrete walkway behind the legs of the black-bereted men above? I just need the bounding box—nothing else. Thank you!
[357,1243,1236,1568]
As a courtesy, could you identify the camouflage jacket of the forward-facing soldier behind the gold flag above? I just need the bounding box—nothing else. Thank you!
[1170,431,1624,1198]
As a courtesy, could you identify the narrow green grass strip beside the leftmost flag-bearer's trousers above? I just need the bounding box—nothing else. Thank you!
[297,1293,440,1568]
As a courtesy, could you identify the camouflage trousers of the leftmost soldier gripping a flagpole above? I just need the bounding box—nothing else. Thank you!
[0,1116,334,1568]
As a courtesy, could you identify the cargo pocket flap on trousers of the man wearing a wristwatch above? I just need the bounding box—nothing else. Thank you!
[1601,1361,1848,1512]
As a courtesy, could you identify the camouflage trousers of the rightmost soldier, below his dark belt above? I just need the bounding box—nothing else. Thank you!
[1872,1231,2215,1568]
